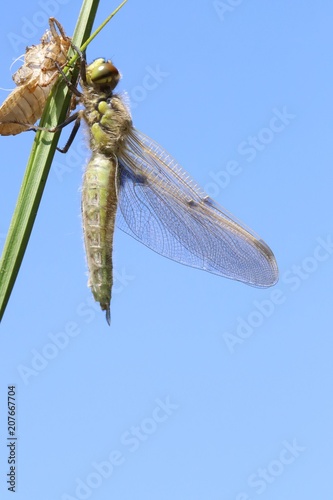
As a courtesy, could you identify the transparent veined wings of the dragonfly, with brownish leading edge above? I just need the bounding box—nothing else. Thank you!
[117,129,278,287]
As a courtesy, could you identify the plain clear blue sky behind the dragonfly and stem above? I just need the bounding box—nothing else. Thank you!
[0,0,333,500]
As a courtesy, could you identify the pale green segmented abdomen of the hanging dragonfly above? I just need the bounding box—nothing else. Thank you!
[82,152,117,323]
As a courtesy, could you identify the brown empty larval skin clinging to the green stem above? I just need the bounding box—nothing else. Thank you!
[0,17,71,135]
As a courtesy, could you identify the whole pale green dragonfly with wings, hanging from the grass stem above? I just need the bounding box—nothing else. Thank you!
[56,57,278,324]
